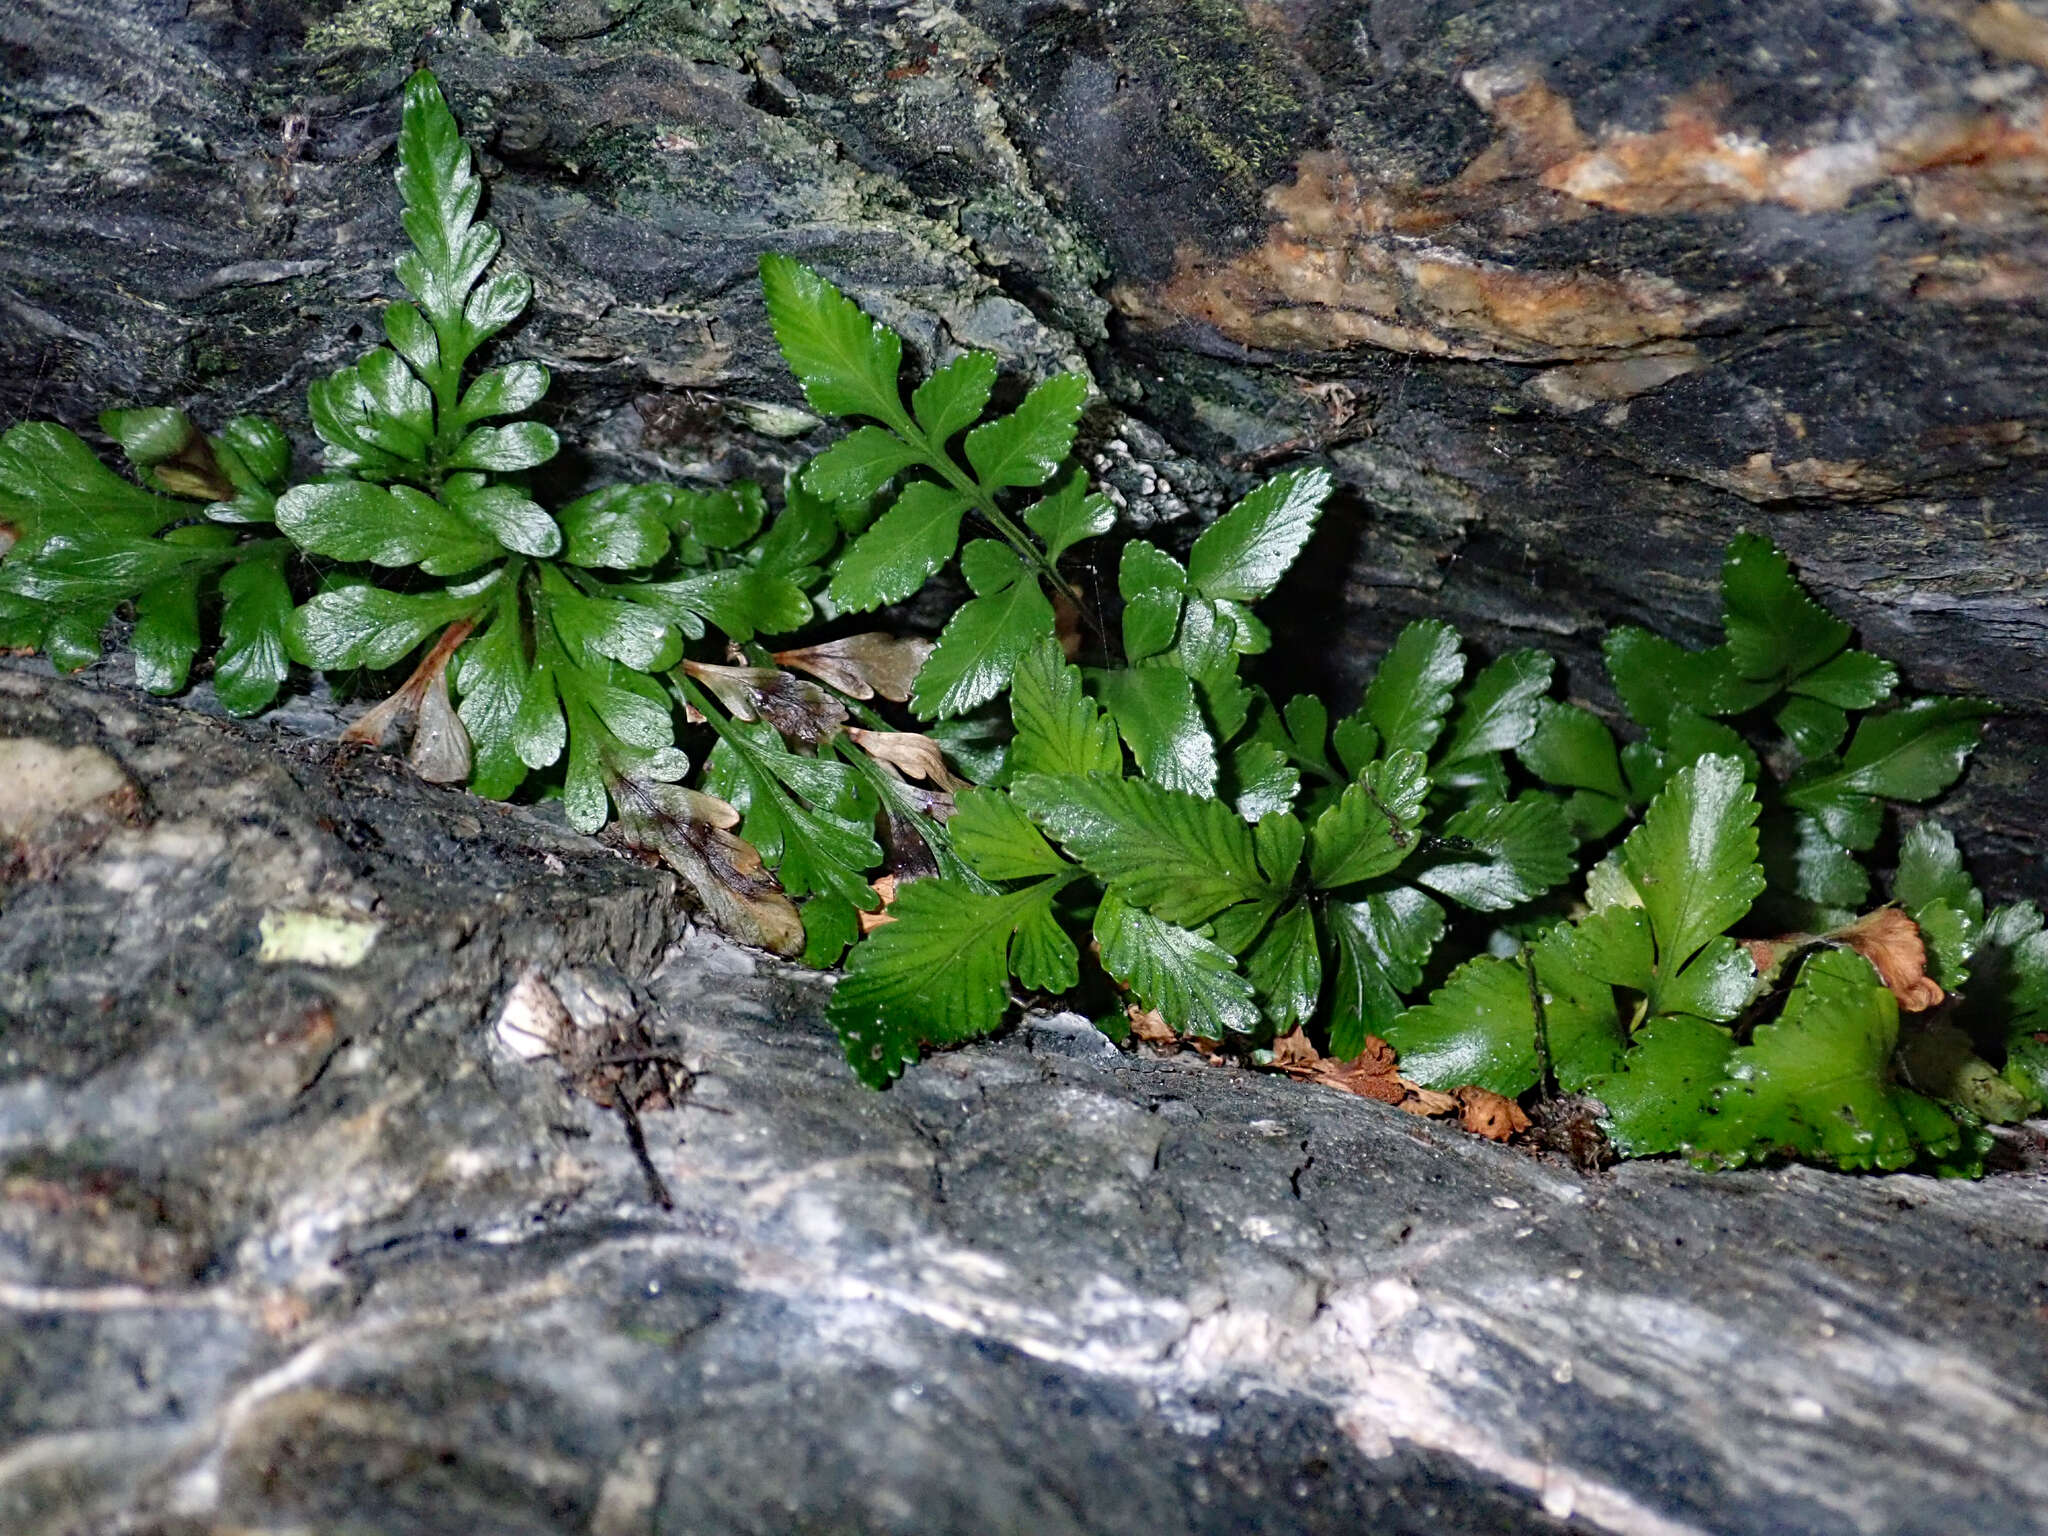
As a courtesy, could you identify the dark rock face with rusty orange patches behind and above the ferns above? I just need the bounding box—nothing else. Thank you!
[0,0,2048,895]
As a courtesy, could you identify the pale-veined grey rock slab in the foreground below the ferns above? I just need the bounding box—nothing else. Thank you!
[0,670,2048,1536]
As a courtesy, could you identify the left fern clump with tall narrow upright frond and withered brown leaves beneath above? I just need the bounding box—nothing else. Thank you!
[0,72,946,952]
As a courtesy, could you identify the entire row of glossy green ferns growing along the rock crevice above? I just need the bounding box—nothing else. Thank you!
[0,72,2048,1171]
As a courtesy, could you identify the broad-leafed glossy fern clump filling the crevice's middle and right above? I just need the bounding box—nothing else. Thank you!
[766,258,2048,1171]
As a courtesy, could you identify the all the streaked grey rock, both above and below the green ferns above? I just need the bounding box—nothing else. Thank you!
[12,0,2048,1536]
